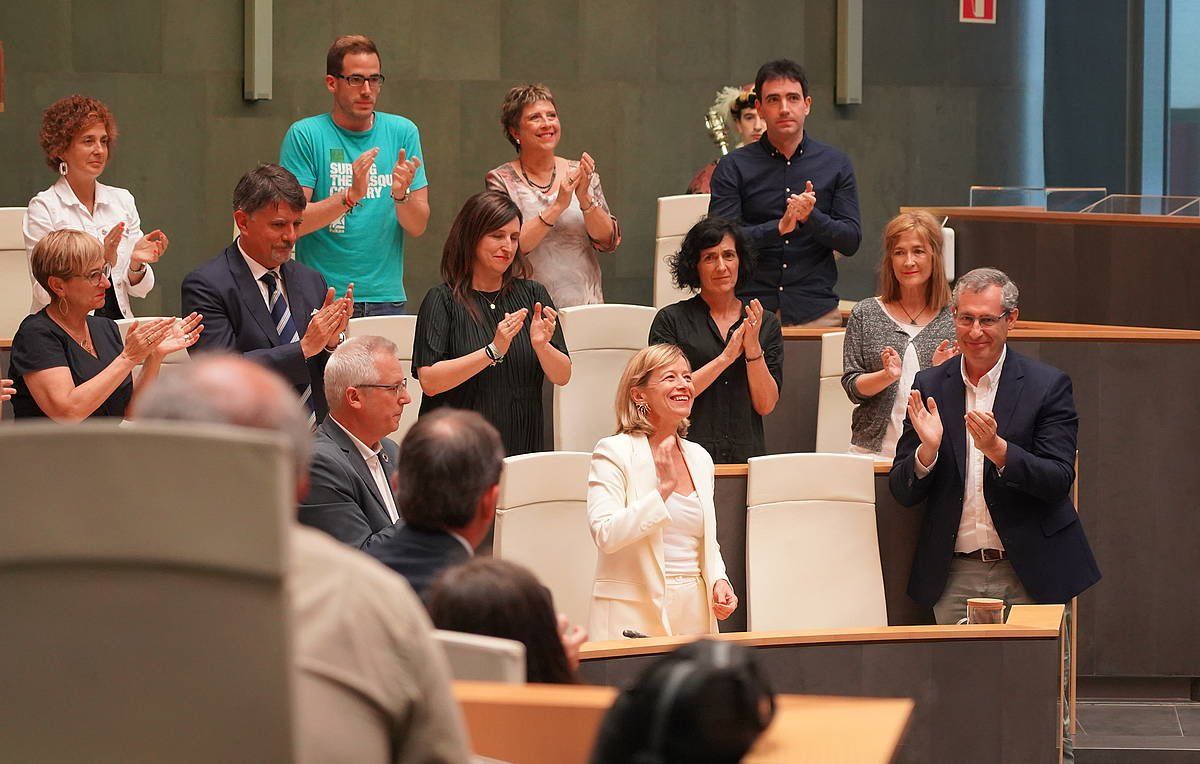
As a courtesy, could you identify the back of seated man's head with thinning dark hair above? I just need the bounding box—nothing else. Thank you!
[396,409,504,530]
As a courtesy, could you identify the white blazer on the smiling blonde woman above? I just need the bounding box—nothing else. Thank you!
[588,434,727,640]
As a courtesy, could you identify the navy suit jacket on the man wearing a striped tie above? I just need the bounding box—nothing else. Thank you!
[181,241,329,422]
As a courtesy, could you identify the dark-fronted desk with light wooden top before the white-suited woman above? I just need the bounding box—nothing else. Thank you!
[580,604,1063,764]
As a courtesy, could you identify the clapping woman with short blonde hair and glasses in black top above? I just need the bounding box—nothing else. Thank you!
[11,229,204,422]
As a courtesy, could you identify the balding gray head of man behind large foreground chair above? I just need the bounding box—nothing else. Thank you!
[133,355,312,483]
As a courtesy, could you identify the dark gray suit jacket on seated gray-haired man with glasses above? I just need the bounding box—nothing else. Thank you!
[298,416,400,549]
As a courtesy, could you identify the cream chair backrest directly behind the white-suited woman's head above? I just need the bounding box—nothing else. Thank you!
[554,305,656,452]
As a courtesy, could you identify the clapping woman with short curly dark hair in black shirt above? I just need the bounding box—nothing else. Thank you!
[649,217,784,464]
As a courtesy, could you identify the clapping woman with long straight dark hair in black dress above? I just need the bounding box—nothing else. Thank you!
[413,191,571,456]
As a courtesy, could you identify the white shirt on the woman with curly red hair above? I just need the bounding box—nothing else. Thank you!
[22,178,154,318]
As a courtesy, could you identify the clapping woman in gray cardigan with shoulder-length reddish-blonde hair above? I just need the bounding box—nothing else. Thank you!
[841,211,958,461]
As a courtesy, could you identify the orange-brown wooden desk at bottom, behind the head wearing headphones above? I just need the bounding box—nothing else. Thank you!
[454,681,913,764]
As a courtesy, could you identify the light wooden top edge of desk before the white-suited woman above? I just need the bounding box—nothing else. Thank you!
[580,604,1063,661]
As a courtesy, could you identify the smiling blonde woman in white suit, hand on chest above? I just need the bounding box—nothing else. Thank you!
[588,344,738,639]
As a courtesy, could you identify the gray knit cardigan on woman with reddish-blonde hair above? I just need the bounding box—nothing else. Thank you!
[841,297,954,453]
